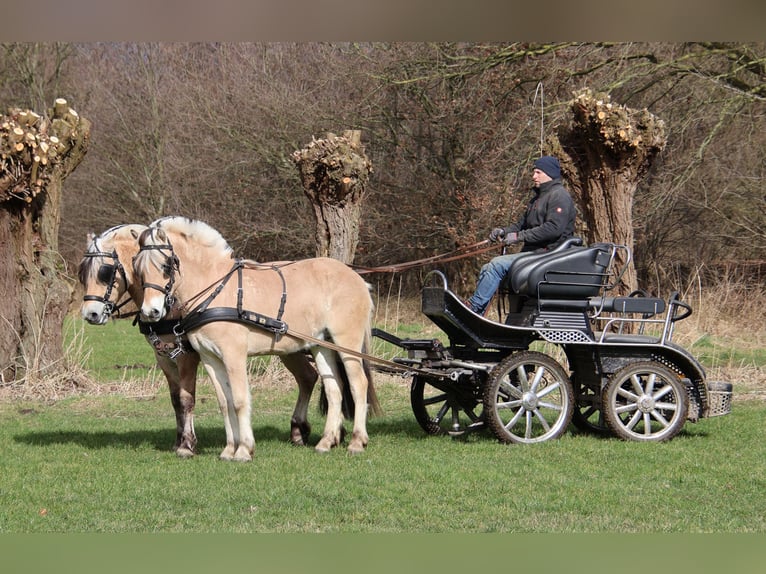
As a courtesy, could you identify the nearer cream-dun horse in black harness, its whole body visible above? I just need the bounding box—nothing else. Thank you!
[134,217,379,461]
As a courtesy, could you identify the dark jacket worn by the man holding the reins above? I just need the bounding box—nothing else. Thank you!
[505,178,577,251]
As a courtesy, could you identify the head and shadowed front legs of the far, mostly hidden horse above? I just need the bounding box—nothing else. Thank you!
[78,224,199,458]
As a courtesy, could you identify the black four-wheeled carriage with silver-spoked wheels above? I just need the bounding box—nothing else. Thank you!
[374,238,732,443]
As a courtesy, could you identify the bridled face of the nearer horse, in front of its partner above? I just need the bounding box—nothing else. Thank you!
[133,227,179,322]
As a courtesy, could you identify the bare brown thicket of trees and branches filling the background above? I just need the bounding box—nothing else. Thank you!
[0,43,766,292]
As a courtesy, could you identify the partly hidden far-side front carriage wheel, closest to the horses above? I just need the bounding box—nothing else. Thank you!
[410,374,484,436]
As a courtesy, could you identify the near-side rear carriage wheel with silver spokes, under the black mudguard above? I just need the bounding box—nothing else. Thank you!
[602,361,689,442]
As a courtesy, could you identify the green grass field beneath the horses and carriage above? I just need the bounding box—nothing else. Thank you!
[0,302,766,533]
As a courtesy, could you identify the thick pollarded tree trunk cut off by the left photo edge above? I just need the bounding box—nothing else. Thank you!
[0,99,90,382]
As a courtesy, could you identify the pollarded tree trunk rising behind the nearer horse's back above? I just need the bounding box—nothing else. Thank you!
[293,131,372,264]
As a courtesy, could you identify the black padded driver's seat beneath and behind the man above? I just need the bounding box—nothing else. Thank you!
[511,243,613,299]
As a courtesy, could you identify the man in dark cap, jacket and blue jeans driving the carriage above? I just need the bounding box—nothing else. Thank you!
[468,155,577,315]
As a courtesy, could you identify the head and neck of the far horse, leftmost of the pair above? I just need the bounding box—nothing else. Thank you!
[77,225,145,325]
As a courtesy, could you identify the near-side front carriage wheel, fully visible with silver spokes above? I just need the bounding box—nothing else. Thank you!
[484,351,574,443]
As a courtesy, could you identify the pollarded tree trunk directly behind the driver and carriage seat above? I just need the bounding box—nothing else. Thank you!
[548,89,666,294]
